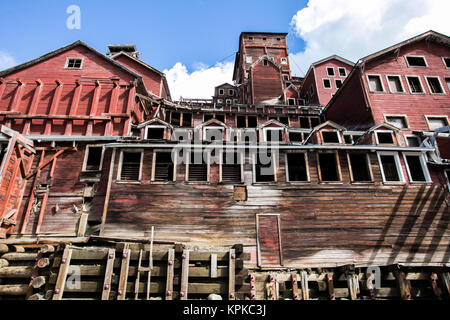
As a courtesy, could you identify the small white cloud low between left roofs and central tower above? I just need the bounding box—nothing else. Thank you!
[164,62,234,100]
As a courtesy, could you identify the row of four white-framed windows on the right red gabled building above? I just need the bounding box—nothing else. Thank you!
[367,75,450,94]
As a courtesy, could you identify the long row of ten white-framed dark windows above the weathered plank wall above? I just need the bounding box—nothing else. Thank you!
[118,150,431,183]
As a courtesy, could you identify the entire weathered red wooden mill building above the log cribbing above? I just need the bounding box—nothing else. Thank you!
[0,32,450,300]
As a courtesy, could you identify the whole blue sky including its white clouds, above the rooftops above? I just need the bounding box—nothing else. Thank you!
[0,0,450,99]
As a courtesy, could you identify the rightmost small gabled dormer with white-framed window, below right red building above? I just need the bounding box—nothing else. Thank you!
[355,122,400,146]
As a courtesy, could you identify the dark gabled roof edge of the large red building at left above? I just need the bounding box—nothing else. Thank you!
[0,40,142,80]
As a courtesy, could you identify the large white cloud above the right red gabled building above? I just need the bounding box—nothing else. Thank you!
[290,0,450,75]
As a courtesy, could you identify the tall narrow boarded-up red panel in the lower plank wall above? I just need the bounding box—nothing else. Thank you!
[256,214,283,266]
